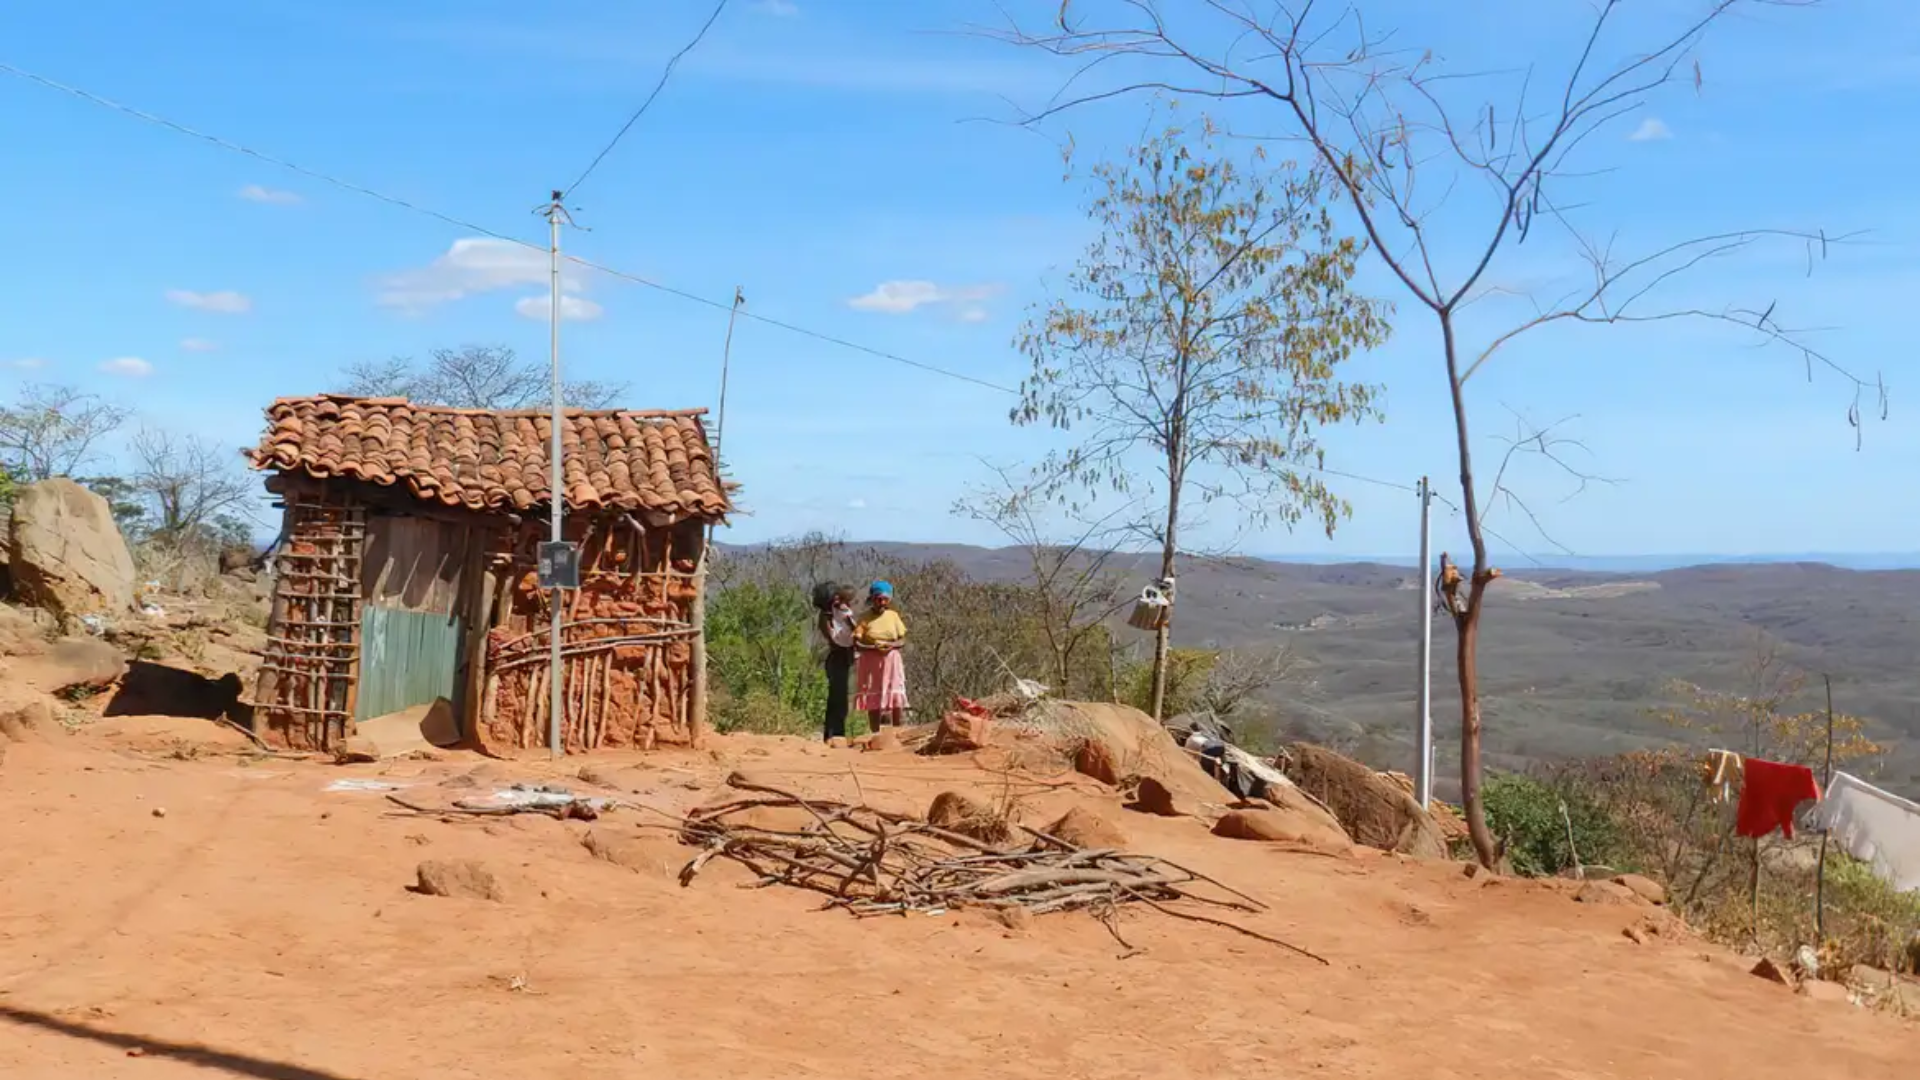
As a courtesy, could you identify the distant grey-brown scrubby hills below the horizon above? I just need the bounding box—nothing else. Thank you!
[721,544,1920,790]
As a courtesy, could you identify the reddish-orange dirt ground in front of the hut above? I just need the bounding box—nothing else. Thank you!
[0,721,1920,1080]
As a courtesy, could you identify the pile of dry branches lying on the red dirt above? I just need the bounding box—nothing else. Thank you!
[680,773,1327,965]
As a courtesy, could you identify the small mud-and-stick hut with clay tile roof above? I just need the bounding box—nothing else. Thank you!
[252,394,732,753]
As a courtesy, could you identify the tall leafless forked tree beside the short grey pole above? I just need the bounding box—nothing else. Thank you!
[996,0,1885,863]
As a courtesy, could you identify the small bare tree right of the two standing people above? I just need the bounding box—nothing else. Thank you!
[954,461,1135,694]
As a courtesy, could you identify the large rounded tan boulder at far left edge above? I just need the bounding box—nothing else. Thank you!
[8,479,136,619]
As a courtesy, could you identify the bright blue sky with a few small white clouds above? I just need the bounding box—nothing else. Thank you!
[0,0,1920,555]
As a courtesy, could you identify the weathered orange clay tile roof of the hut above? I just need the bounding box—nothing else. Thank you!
[250,394,733,519]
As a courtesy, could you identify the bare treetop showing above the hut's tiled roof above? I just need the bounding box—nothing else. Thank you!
[346,346,626,409]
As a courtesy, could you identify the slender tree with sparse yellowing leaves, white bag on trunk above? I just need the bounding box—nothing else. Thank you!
[1012,129,1386,719]
